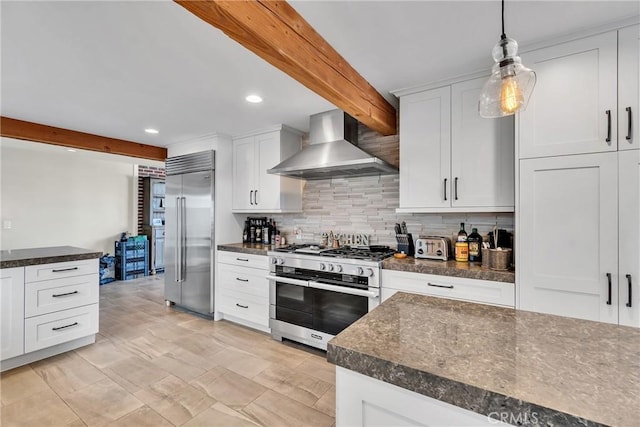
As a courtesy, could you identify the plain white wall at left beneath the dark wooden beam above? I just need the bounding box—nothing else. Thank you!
[0,138,164,254]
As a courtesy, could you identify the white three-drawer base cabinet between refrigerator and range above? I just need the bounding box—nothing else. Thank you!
[216,251,269,331]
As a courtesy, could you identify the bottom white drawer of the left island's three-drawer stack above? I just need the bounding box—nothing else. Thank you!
[24,304,98,353]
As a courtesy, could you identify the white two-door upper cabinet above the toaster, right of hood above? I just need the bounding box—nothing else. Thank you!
[398,78,515,212]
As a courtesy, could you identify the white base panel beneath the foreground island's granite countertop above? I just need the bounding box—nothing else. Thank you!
[336,366,509,427]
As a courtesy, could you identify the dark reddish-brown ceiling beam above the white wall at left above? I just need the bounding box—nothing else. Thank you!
[0,117,167,162]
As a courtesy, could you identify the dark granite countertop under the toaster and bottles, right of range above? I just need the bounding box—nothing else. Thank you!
[382,257,516,283]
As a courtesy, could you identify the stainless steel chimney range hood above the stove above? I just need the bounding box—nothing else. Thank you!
[267,110,398,179]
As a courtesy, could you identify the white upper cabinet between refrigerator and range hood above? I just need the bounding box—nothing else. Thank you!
[233,126,302,213]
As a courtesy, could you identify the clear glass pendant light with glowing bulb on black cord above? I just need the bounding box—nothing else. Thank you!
[478,0,536,118]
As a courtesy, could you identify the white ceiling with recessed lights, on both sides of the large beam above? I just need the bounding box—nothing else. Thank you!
[0,0,640,146]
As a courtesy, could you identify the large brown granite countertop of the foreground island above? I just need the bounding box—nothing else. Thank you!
[327,292,640,426]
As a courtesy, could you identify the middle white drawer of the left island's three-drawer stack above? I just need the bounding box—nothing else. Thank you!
[24,274,99,317]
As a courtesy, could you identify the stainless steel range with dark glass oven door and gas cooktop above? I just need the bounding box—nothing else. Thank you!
[268,245,394,350]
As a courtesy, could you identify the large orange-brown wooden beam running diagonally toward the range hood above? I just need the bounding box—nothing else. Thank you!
[174,0,397,135]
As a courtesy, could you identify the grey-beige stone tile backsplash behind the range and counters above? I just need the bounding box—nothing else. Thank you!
[262,125,513,247]
